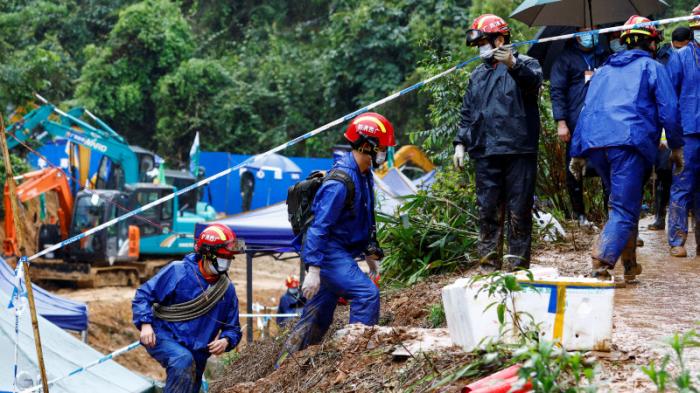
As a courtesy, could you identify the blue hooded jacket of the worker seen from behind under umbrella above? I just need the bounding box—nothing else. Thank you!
[571,49,683,165]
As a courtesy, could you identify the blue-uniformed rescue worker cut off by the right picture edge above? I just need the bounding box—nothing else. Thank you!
[666,5,700,257]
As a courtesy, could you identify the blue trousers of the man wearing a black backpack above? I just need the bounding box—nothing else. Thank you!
[278,251,379,365]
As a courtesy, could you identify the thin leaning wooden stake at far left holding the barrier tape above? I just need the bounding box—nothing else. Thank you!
[0,115,49,393]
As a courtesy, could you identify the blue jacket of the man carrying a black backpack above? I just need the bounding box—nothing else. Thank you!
[295,152,375,267]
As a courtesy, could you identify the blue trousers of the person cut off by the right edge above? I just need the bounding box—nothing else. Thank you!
[668,135,700,247]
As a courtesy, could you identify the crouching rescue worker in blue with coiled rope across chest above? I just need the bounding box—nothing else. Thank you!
[132,224,241,393]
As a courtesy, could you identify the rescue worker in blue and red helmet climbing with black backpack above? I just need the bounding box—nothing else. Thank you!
[276,113,396,366]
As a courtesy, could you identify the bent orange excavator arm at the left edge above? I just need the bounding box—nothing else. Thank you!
[3,168,73,255]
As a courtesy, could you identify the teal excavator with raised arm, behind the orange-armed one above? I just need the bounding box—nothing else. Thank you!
[7,96,216,256]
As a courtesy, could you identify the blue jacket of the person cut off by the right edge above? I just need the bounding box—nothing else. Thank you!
[666,41,700,135]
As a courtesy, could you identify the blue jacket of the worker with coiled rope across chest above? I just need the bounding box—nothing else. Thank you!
[132,254,241,351]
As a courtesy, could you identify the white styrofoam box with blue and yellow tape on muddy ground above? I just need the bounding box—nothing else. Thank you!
[442,269,615,351]
